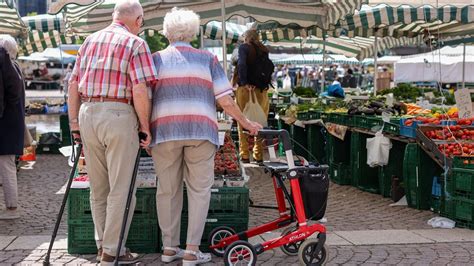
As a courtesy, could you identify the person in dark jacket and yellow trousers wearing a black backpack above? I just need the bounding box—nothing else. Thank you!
[234,30,270,163]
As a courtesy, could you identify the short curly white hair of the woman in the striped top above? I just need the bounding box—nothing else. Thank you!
[163,7,201,42]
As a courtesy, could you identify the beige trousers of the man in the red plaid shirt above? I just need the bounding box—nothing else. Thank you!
[79,102,139,256]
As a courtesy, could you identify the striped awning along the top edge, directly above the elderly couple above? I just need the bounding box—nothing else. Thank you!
[50,0,365,35]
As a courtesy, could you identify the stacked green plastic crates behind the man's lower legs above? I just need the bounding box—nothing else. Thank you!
[68,188,161,254]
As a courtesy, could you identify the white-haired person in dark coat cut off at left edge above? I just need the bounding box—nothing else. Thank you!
[0,35,25,220]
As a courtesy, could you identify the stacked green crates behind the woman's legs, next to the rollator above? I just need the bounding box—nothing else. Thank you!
[181,187,249,251]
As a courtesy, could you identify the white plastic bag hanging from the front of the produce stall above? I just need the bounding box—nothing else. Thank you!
[366,131,392,167]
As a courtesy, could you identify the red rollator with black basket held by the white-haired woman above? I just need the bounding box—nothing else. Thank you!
[209,130,329,265]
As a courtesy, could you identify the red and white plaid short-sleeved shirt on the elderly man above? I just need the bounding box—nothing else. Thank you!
[69,22,158,99]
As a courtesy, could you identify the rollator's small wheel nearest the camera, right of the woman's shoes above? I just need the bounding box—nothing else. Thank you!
[224,240,257,266]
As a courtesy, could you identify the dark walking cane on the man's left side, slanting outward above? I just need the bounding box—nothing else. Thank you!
[43,131,82,266]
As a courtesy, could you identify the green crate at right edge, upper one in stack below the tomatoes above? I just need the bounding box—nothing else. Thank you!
[446,168,474,200]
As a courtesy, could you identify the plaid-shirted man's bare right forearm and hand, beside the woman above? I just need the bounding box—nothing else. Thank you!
[133,82,151,147]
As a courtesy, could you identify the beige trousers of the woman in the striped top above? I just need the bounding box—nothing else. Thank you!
[152,140,216,247]
